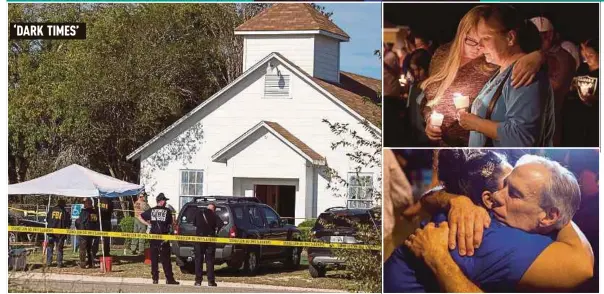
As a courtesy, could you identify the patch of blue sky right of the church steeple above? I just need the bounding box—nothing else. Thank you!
[318,2,382,79]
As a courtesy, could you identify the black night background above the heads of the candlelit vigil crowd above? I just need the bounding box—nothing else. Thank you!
[384,3,600,45]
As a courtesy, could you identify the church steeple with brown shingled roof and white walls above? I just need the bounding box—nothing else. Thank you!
[235,3,350,83]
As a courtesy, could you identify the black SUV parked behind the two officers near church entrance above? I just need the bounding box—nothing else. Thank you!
[172,196,302,275]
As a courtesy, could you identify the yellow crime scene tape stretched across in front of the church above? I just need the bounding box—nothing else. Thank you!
[8,226,382,251]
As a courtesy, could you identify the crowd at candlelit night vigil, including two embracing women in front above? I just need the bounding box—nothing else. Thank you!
[383,4,600,147]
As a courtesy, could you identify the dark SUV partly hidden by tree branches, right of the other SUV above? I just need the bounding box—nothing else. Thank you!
[308,207,381,278]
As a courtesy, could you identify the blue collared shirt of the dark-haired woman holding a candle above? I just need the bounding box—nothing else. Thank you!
[469,64,554,147]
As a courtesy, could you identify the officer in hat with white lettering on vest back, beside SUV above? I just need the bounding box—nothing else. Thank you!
[138,193,180,285]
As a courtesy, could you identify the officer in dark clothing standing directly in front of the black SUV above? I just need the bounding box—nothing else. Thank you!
[194,203,221,287]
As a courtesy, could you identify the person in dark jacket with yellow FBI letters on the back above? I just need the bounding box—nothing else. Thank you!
[46,199,71,267]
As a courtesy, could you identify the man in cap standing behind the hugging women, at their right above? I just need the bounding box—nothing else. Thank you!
[531,16,576,146]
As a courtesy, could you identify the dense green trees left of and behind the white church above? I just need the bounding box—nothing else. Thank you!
[8,4,256,206]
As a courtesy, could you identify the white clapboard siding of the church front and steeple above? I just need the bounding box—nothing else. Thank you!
[140,51,381,223]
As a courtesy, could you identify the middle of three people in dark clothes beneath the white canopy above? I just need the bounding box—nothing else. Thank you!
[76,198,99,268]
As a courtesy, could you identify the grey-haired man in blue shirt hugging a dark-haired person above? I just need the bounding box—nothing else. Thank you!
[384,156,593,292]
